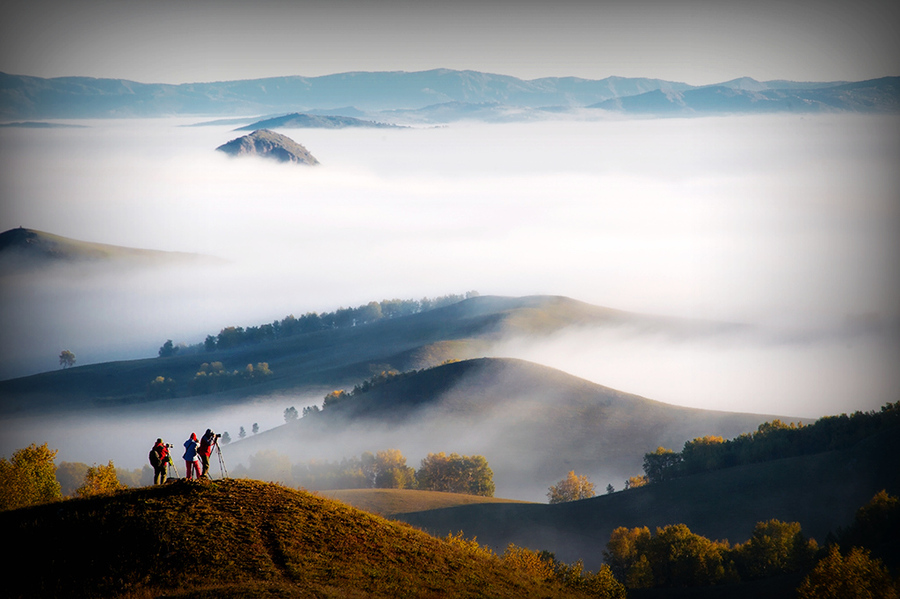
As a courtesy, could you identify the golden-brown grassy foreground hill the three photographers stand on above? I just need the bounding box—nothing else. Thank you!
[0,480,604,599]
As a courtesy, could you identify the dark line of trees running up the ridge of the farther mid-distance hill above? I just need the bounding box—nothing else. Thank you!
[159,291,478,358]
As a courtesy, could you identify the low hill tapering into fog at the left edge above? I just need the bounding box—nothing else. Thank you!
[0,227,215,273]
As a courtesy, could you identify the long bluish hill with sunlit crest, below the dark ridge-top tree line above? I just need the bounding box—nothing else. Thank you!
[0,296,732,413]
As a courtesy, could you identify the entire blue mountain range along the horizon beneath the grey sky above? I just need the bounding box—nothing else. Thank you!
[0,69,900,122]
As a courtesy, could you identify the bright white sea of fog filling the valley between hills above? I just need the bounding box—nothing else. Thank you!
[0,115,900,478]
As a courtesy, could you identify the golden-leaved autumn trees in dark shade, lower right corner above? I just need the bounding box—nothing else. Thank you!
[603,491,900,599]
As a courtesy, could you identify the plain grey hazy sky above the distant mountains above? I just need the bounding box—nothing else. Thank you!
[0,0,900,84]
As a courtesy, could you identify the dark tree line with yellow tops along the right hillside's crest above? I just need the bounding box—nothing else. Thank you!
[644,402,900,483]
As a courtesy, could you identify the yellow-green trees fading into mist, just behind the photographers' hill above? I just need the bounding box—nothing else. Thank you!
[232,449,494,497]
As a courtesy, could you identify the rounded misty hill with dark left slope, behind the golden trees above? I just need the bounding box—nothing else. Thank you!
[227,358,788,501]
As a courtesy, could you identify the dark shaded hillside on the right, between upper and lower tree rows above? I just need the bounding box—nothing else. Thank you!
[395,430,900,568]
